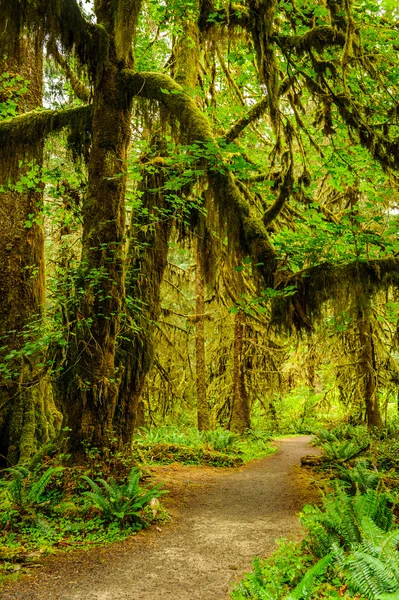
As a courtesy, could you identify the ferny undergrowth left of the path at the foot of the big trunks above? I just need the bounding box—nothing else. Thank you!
[0,449,168,582]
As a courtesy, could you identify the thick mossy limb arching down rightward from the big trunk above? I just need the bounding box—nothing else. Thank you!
[121,69,277,286]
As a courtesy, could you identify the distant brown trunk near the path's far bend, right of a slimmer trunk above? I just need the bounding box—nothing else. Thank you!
[230,310,251,433]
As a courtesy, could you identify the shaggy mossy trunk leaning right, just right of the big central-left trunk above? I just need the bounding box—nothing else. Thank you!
[114,159,172,448]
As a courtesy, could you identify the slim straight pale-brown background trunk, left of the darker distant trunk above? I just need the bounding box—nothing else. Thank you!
[195,237,210,431]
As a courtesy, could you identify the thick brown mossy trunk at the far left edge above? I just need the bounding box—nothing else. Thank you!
[0,30,60,464]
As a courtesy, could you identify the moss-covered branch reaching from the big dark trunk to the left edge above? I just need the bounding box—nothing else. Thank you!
[0,105,92,156]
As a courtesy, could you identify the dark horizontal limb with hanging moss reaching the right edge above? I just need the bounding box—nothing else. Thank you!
[272,258,399,330]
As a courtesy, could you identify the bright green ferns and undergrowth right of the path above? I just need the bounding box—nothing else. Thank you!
[231,425,399,600]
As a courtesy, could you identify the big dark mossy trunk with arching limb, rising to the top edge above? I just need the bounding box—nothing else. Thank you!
[58,0,140,462]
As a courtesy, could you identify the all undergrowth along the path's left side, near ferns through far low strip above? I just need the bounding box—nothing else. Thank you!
[0,427,274,581]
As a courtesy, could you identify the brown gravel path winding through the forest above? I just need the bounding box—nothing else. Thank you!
[0,436,318,600]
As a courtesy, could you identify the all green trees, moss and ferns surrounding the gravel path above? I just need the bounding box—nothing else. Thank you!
[0,0,399,600]
